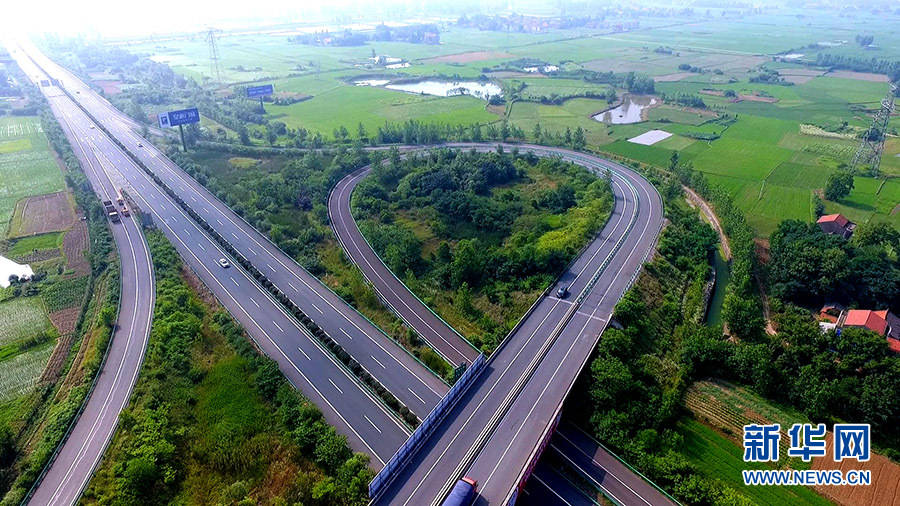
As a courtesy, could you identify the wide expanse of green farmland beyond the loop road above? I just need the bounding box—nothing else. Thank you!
[107,9,900,237]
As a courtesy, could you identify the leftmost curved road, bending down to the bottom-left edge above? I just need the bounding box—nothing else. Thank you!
[13,48,155,505]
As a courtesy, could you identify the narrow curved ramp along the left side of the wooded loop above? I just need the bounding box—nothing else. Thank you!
[328,165,479,366]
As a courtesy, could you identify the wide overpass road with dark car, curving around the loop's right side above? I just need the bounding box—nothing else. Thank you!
[348,144,663,504]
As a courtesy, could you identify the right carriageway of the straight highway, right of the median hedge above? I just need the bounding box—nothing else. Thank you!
[16,39,449,422]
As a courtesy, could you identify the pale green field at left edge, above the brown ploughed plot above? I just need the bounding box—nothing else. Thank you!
[0,116,65,237]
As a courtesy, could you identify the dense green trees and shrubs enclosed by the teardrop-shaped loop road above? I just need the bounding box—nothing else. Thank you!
[352,146,612,351]
